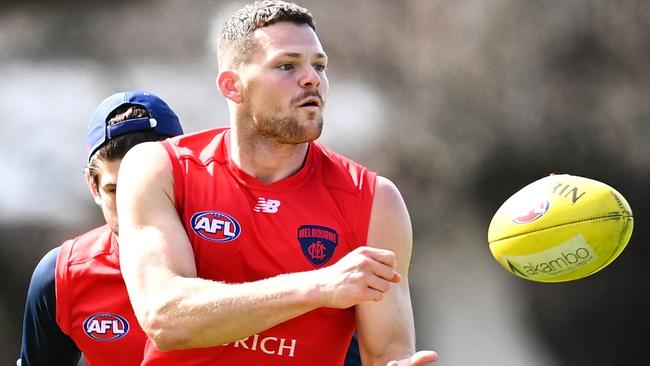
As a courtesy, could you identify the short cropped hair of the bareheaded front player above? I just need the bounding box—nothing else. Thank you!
[218,0,316,66]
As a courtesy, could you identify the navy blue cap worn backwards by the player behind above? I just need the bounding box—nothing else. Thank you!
[87,91,183,161]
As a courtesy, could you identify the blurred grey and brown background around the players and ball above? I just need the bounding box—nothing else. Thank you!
[0,0,650,366]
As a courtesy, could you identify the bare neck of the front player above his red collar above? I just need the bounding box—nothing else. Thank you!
[228,128,309,184]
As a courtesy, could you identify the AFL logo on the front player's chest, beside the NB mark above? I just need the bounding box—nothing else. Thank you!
[190,211,241,243]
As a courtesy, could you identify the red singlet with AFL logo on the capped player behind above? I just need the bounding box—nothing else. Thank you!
[55,225,146,366]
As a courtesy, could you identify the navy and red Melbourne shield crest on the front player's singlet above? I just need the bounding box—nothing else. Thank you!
[298,225,339,266]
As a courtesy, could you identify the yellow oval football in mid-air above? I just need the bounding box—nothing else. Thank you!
[488,174,634,282]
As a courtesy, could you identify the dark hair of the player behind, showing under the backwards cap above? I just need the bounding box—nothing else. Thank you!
[88,104,168,184]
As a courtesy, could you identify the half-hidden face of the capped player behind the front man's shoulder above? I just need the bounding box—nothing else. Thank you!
[86,159,122,234]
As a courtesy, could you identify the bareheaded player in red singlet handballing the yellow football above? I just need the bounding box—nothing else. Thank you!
[117,1,437,366]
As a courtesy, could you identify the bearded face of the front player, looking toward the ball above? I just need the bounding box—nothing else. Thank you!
[240,22,329,144]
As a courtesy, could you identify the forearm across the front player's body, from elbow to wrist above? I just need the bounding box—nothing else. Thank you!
[141,271,322,350]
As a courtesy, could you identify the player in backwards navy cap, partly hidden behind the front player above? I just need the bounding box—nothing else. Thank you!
[18,91,183,366]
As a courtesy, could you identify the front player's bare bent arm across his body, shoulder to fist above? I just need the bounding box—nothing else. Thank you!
[117,143,399,350]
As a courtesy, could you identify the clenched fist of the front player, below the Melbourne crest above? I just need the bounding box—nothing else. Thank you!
[315,246,401,309]
